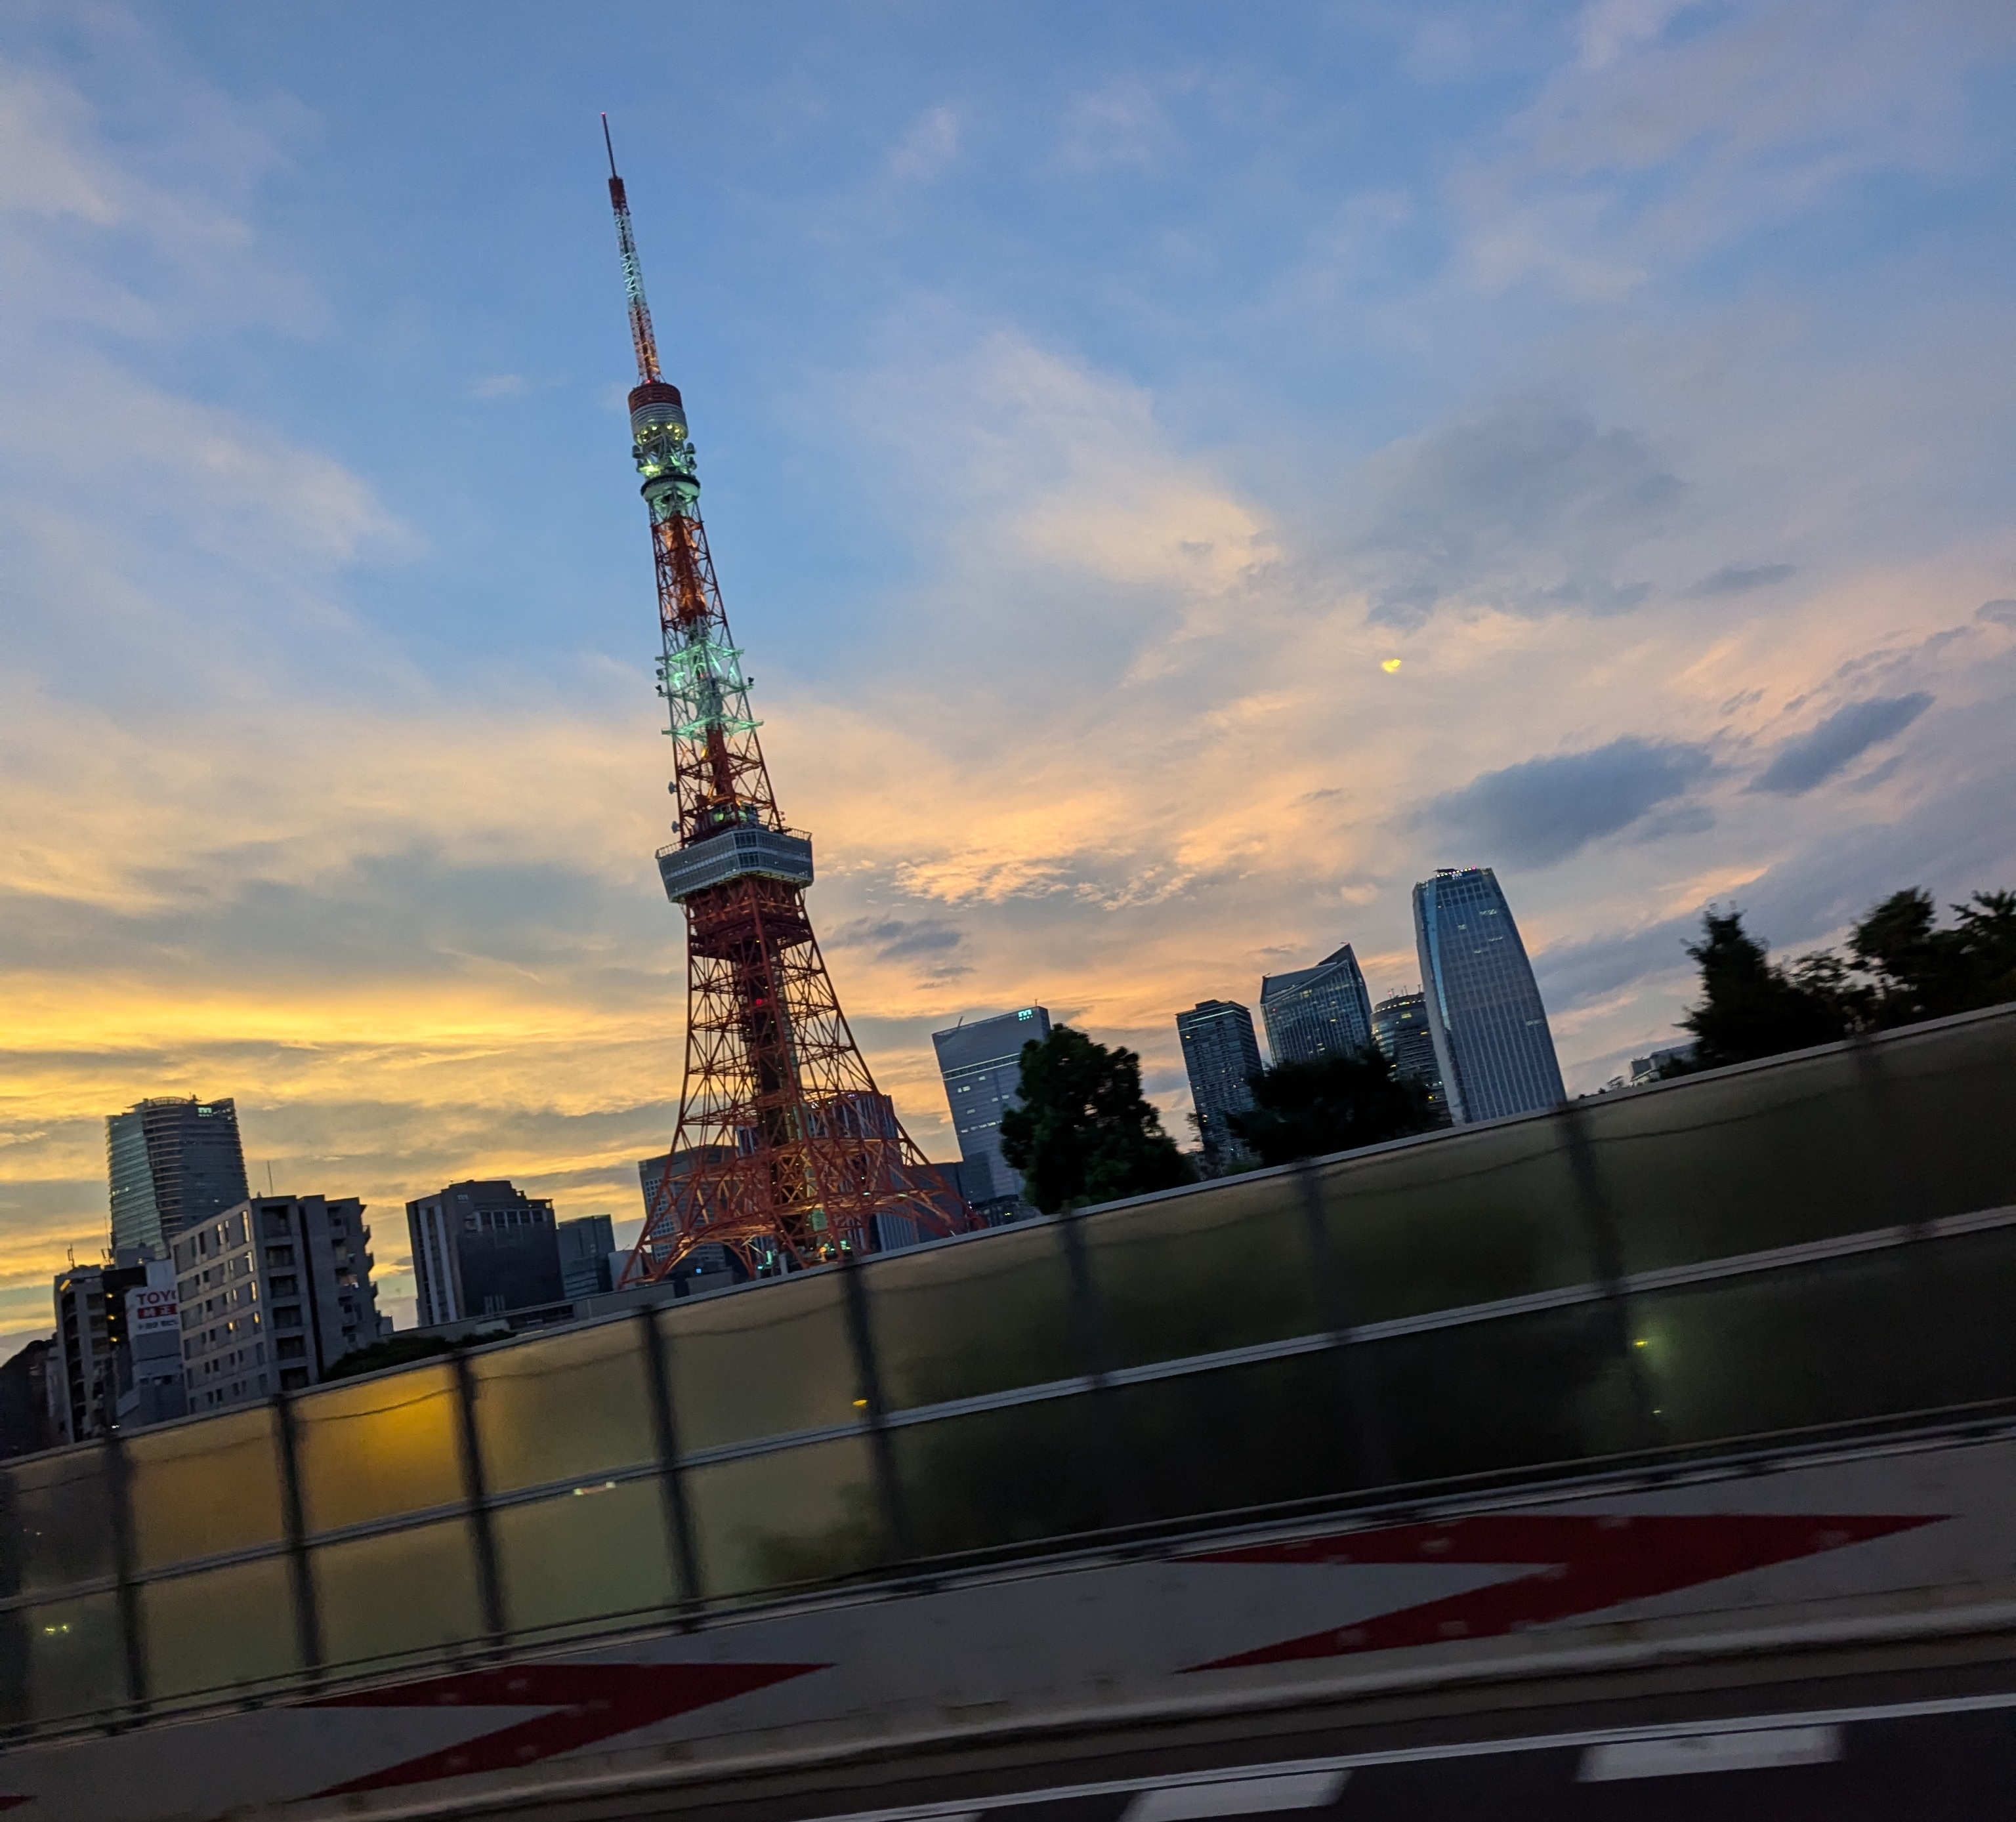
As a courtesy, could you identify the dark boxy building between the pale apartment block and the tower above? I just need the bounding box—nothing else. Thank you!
[405,1177,564,1328]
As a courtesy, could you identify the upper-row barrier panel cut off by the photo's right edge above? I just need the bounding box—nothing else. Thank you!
[1869,1008,2016,1222]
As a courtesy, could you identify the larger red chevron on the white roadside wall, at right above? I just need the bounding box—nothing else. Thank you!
[1185,1512,1943,1675]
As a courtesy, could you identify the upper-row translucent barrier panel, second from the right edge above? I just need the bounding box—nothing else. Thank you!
[1583,1050,1903,1272]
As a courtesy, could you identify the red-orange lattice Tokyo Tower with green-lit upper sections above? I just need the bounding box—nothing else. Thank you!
[603,115,976,1284]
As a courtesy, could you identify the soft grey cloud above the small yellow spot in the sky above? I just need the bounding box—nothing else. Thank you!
[1359,399,1687,627]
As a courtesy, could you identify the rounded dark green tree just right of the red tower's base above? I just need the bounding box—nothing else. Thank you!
[1002,1026,1194,1215]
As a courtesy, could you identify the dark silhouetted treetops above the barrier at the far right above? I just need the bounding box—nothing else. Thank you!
[1681,887,2016,1068]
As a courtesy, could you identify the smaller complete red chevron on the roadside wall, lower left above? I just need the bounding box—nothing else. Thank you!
[310,1665,829,1798]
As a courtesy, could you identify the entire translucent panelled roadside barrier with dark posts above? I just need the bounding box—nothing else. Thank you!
[0,1008,2016,1739]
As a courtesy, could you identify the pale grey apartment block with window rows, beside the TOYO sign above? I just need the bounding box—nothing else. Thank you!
[173,1195,391,1415]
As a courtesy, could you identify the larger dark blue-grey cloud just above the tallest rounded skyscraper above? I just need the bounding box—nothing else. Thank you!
[1416,735,1713,867]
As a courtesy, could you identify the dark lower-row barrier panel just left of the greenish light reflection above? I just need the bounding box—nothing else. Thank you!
[1353,1304,1653,1481]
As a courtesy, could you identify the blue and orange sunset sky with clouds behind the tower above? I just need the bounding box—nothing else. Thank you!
[0,0,2016,1352]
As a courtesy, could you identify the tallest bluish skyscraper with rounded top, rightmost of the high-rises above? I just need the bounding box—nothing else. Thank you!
[1413,867,1566,1125]
